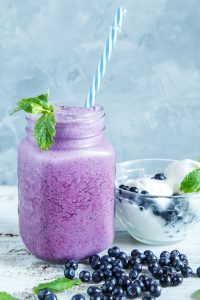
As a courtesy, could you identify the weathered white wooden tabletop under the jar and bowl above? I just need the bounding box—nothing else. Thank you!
[0,186,200,300]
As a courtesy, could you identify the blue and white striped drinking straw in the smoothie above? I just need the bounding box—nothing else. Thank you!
[84,7,126,108]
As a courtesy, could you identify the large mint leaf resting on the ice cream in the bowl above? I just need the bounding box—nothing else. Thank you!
[180,169,200,193]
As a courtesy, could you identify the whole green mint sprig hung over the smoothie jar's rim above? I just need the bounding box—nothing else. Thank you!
[11,94,56,150]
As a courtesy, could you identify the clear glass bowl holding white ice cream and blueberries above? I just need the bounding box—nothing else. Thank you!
[116,159,200,245]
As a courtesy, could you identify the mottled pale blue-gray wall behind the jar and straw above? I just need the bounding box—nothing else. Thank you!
[0,0,200,184]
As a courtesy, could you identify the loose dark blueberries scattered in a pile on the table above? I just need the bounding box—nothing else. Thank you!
[38,246,200,300]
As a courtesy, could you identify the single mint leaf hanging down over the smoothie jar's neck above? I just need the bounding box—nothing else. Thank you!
[34,112,56,150]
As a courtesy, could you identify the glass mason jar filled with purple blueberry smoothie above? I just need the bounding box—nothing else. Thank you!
[18,106,115,262]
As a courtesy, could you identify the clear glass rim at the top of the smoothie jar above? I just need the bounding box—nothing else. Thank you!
[26,101,105,125]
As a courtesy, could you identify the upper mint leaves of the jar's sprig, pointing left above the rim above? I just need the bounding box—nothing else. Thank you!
[10,94,52,115]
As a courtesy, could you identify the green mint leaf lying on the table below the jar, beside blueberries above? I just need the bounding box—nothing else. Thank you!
[34,277,81,294]
